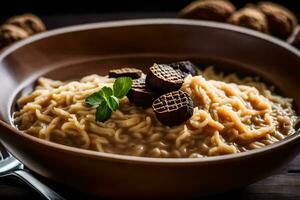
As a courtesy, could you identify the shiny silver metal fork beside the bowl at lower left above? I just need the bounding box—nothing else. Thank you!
[0,143,64,200]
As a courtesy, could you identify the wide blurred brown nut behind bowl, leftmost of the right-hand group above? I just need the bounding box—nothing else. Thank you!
[179,0,235,22]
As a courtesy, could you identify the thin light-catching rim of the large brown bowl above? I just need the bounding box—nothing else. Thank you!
[0,18,300,165]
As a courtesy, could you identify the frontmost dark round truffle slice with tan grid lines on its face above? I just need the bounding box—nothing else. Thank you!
[152,90,193,126]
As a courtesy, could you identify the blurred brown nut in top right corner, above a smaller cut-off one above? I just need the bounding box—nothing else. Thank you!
[258,2,297,39]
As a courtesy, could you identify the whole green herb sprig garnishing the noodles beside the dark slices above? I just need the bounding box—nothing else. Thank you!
[85,77,132,122]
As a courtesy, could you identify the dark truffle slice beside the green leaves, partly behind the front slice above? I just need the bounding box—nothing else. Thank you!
[127,78,159,107]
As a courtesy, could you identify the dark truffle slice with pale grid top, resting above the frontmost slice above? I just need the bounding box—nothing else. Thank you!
[146,64,184,93]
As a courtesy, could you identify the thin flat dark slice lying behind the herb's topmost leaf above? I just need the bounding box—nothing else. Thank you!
[108,67,143,79]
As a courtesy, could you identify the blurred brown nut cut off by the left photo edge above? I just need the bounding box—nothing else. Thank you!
[0,24,29,48]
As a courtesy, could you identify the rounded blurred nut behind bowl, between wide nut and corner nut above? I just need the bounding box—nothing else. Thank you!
[228,6,268,33]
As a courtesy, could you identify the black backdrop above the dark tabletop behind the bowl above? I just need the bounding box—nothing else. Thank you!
[0,0,300,20]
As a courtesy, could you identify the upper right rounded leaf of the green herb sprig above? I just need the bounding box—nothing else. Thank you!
[113,77,132,98]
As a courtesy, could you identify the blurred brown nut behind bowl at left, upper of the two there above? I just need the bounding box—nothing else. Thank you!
[6,14,46,35]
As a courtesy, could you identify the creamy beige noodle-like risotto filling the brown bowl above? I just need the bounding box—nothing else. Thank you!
[14,68,297,158]
